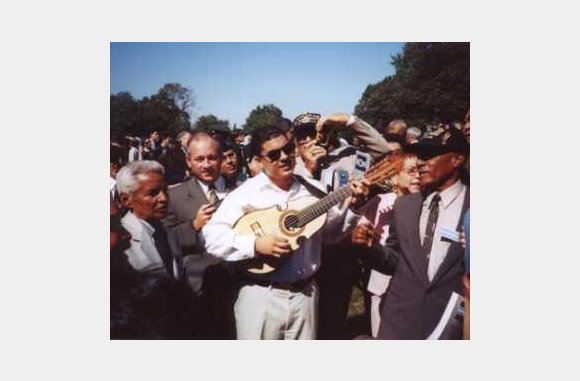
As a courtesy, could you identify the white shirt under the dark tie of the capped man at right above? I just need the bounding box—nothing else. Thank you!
[419,180,467,280]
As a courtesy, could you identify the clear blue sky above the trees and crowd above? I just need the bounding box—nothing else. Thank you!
[111,42,403,126]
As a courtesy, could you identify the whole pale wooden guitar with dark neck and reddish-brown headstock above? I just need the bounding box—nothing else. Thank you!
[233,154,403,274]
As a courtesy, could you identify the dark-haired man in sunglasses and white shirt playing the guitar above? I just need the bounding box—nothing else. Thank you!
[202,126,368,339]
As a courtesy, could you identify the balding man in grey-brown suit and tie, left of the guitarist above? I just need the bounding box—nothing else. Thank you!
[164,132,235,338]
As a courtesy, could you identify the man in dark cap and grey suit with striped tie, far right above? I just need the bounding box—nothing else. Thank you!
[372,124,469,339]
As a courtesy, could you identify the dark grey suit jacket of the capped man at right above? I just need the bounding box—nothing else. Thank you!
[378,187,469,340]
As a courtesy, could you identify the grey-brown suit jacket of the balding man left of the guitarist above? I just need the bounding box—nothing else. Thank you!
[163,178,220,293]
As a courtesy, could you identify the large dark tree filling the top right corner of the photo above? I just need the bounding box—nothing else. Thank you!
[355,42,469,127]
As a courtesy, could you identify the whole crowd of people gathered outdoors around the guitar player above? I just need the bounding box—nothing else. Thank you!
[110,112,470,339]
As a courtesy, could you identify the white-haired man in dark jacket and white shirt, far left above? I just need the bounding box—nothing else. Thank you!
[111,160,202,339]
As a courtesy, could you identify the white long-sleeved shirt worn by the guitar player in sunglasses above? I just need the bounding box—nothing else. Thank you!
[202,172,360,283]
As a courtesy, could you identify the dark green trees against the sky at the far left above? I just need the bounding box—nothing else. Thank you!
[110,83,194,135]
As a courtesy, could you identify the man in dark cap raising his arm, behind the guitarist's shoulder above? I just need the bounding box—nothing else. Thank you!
[293,112,391,339]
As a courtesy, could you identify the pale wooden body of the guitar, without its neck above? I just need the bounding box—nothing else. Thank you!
[233,196,326,274]
